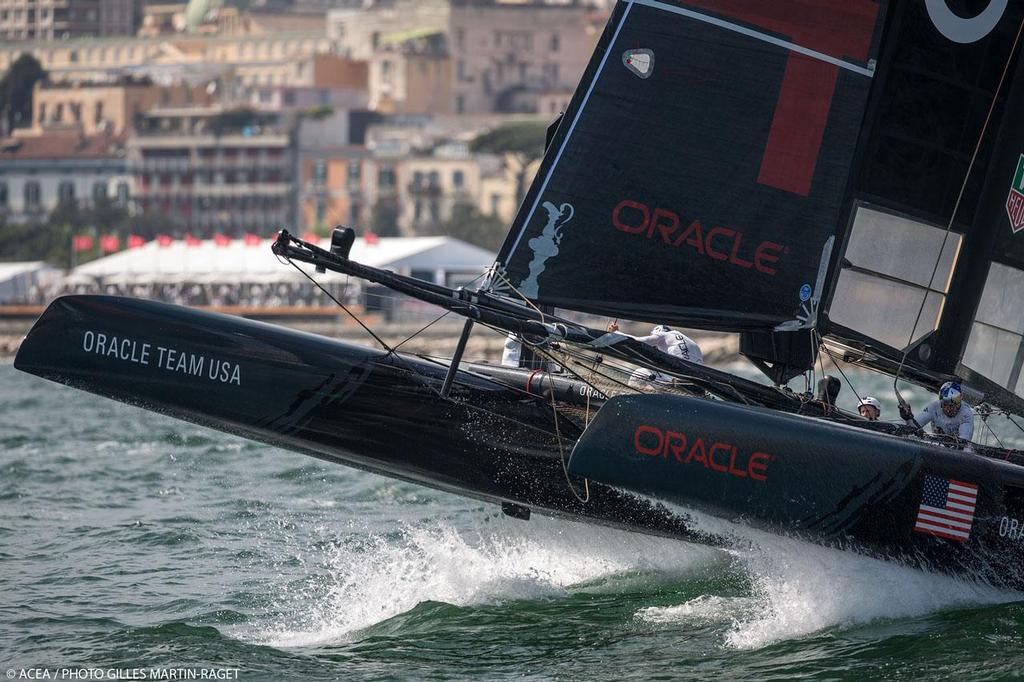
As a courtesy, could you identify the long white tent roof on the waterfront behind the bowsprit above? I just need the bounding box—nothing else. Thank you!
[73,237,495,284]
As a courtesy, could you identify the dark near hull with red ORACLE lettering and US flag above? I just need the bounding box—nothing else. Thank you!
[569,395,1024,589]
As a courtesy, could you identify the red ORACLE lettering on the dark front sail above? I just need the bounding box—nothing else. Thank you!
[611,199,787,275]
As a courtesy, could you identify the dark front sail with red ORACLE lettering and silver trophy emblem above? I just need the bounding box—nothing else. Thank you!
[494,0,883,331]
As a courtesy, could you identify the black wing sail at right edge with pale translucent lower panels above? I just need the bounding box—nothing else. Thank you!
[822,0,1024,411]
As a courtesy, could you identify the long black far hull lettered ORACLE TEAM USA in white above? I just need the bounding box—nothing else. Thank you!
[14,296,714,542]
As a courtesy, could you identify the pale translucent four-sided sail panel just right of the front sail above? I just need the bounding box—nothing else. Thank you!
[828,205,963,349]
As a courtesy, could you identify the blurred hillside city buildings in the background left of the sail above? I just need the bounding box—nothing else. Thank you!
[0,0,607,237]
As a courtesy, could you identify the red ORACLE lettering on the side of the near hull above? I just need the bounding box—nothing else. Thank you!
[633,424,771,482]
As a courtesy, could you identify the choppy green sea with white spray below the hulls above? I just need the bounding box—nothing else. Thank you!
[6,366,1024,682]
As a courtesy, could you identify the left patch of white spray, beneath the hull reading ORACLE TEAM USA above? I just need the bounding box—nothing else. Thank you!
[255,517,728,647]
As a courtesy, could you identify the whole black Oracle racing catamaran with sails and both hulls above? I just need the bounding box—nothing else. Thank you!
[15,0,1024,588]
